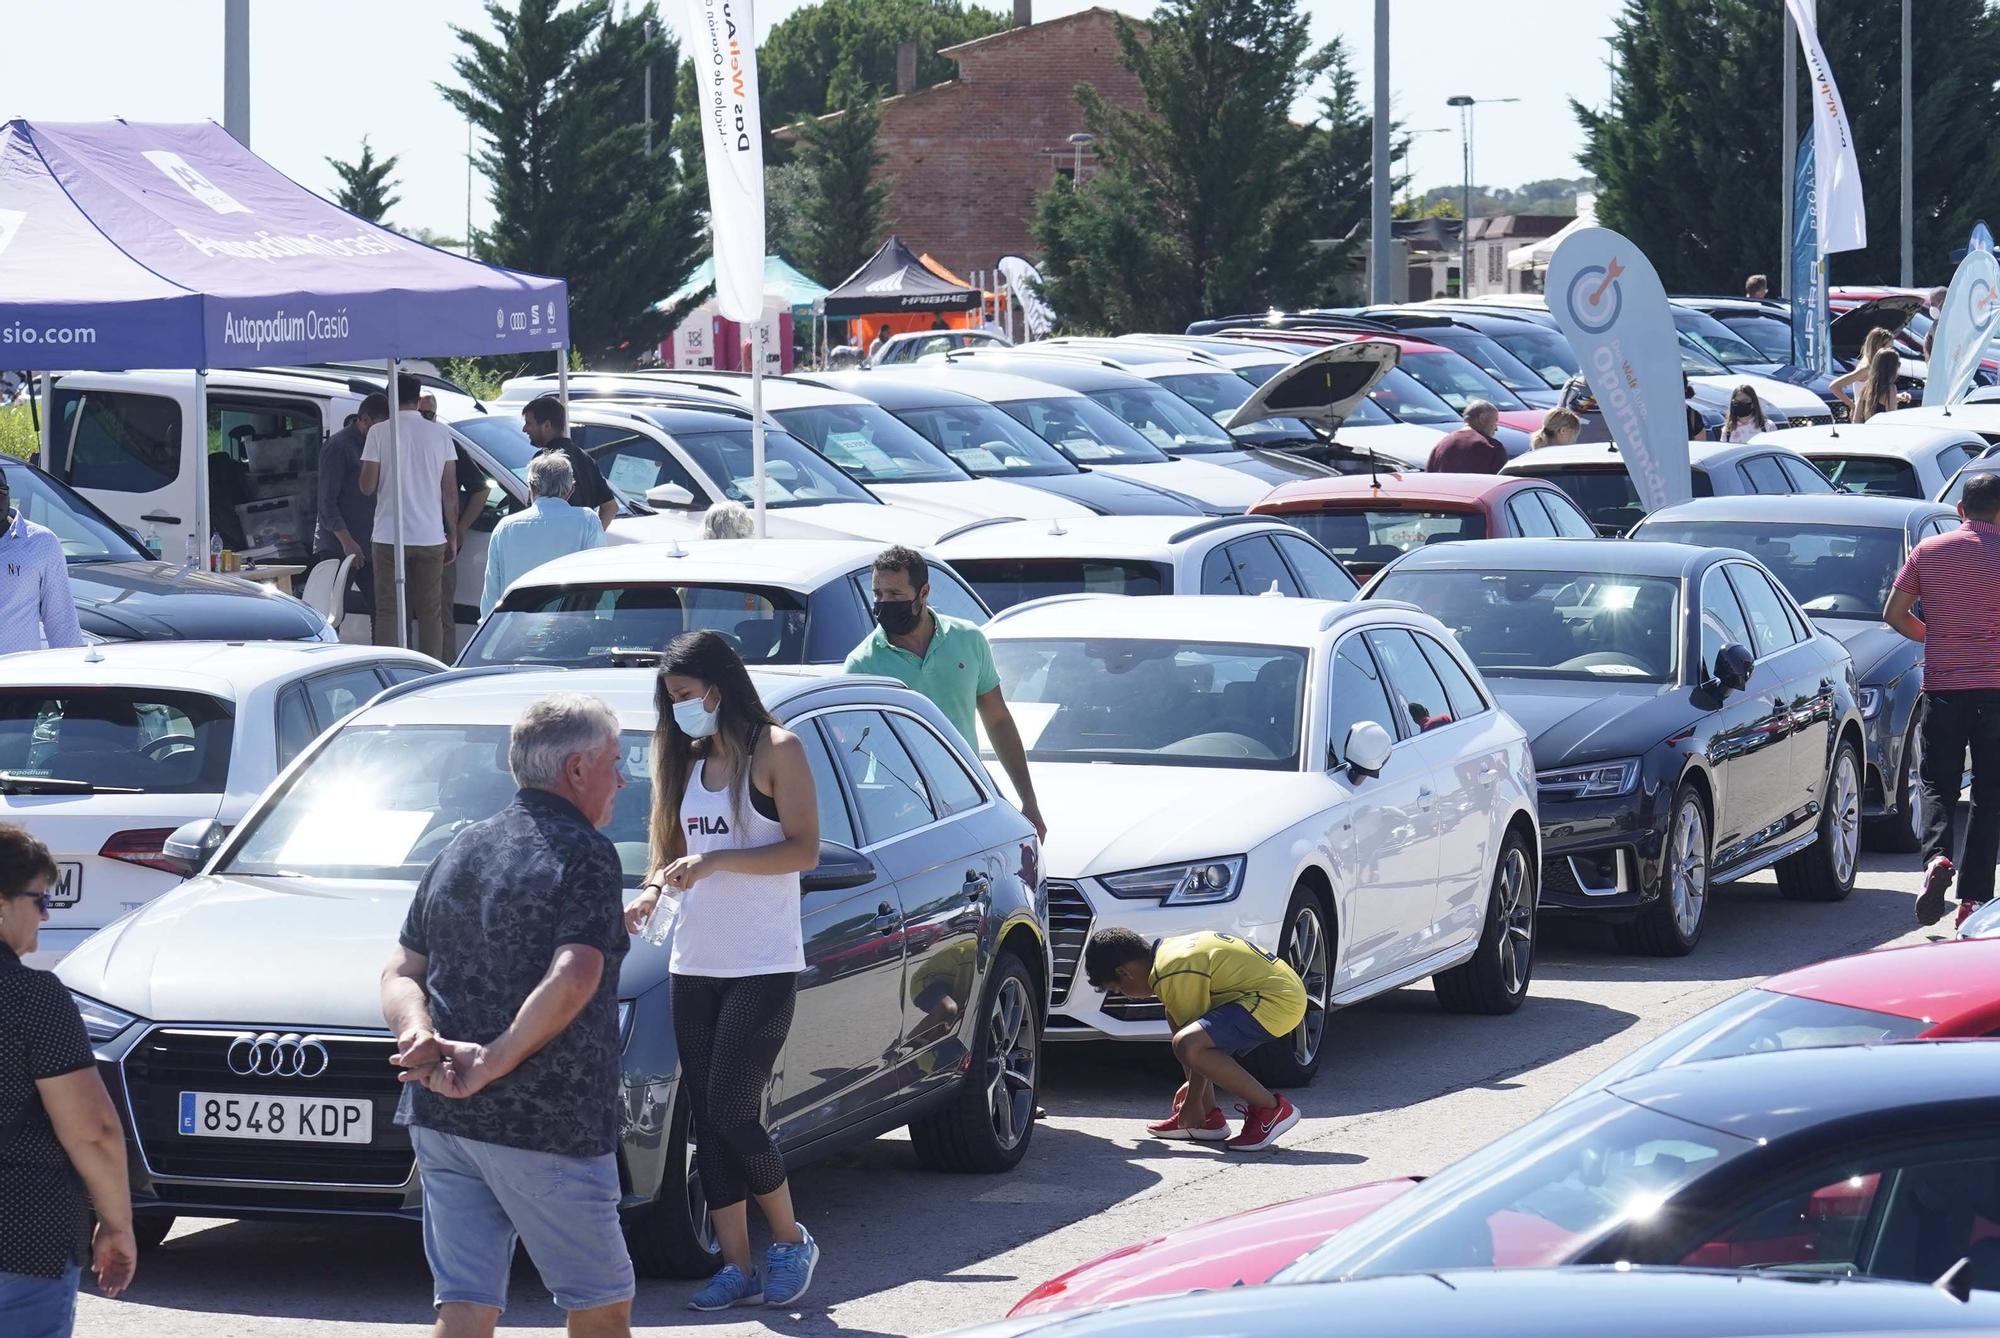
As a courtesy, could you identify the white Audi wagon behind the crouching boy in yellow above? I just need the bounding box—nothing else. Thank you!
[986,596,1540,1084]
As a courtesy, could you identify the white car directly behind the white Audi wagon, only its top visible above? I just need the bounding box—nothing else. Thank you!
[938,516,1358,610]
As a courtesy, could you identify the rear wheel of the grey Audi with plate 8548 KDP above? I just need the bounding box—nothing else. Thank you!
[910,952,1042,1176]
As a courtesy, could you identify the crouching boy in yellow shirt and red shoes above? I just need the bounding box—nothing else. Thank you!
[1084,928,1306,1152]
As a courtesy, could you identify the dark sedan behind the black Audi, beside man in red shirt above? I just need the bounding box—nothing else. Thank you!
[1632,496,1958,854]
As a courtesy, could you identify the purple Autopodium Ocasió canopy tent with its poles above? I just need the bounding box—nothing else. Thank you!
[0,120,570,642]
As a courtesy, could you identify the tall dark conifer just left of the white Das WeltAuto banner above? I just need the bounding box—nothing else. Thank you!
[440,0,706,364]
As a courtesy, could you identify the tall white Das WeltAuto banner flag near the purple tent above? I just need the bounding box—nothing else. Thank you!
[686,0,764,324]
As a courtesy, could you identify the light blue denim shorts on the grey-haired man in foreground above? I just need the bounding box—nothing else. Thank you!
[410,1126,634,1310]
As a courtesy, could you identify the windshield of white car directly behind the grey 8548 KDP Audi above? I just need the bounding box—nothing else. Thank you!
[458,582,806,668]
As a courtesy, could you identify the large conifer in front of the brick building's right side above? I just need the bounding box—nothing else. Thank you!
[1036,0,1346,328]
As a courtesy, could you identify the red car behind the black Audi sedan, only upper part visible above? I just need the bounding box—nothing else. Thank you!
[1250,474,1596,580]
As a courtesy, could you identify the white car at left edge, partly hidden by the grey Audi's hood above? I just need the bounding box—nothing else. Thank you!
[0,642,444,966]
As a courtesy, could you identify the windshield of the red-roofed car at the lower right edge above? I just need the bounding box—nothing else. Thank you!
[1562,988,1924,1102]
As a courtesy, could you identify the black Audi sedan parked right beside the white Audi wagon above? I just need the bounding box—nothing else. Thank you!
[1362,536,1864,956]
